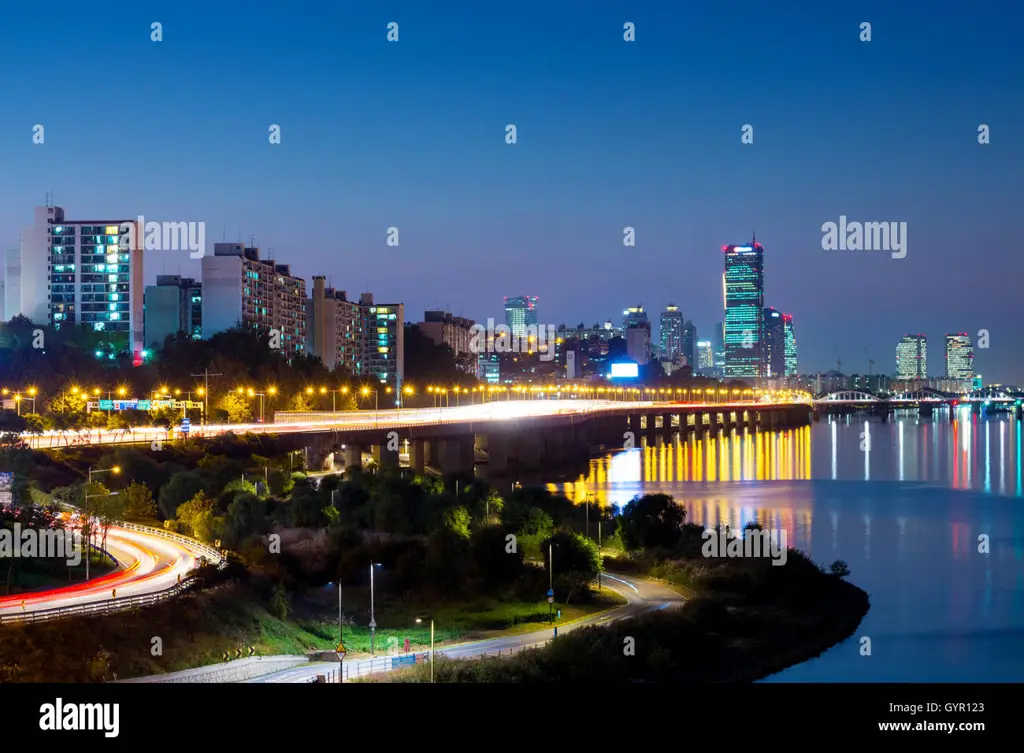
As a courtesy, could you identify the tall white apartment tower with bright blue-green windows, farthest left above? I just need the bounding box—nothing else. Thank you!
[4,205,143,358]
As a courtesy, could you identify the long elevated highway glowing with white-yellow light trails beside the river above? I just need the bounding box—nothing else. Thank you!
[22,400,792,450]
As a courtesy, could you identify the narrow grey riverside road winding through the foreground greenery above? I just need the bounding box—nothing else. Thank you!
[248,574,685,683]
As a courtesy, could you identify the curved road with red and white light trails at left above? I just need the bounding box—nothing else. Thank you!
[0,528,209,618]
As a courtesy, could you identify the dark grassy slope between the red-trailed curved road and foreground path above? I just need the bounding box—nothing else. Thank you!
[0,584,624,682]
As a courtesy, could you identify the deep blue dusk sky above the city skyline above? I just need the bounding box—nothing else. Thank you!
[0,0,1024,382]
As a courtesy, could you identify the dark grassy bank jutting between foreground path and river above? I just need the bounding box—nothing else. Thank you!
[361,551,869,683]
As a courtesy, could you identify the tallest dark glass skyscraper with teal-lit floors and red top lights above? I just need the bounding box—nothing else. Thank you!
[722,239,766,379]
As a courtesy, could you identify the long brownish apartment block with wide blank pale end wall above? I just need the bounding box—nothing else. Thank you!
[203,243,306,360]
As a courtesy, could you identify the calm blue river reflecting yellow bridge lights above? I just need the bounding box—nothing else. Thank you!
[549,412,1024,682]
